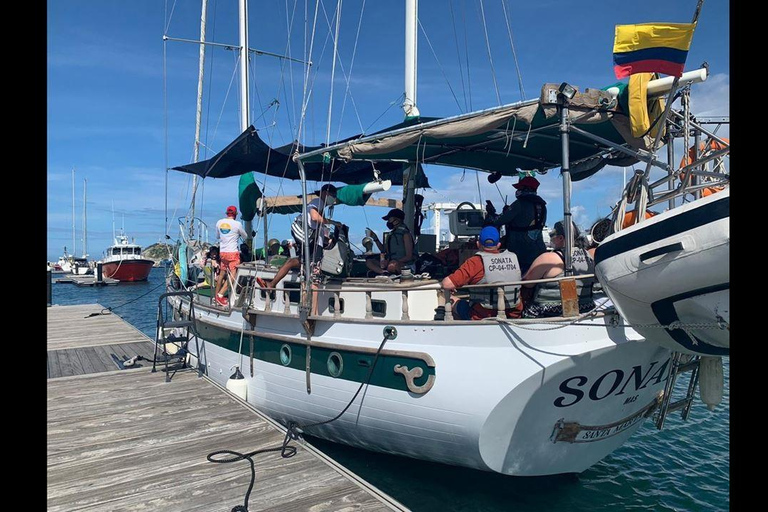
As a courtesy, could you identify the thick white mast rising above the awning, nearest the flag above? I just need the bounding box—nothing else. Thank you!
[403,0,419,233]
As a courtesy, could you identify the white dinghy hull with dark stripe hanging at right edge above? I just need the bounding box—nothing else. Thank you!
[595,189,730,356]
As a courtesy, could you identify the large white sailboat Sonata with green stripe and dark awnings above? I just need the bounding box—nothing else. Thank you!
[160,0,728,476]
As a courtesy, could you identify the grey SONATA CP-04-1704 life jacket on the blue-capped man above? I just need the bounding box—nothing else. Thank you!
[469,251,523,309]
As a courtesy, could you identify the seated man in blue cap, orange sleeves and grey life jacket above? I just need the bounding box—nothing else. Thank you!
[438,226,521,320]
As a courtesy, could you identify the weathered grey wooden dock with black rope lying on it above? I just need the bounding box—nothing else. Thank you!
[47,305,407,512]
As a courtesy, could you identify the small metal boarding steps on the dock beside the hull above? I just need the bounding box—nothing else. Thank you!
[152,291,203,382]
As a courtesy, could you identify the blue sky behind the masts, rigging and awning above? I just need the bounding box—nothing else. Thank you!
[47,0,730,260]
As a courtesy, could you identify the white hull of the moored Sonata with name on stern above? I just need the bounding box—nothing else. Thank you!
[172,298,669,476]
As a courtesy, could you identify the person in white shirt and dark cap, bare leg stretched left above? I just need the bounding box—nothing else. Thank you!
[256,183,339,288]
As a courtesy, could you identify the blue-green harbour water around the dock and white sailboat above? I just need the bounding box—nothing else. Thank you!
[52,268,728,512]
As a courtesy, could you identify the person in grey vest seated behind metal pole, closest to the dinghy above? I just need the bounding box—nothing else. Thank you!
[523,221,595,318]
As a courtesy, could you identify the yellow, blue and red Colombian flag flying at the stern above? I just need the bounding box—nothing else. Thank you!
[613,23,696,78]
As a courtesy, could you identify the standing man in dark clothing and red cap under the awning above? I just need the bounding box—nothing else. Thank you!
[493,176,547,274]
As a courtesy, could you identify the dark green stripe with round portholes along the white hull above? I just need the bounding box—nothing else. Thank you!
[197,322,435,391]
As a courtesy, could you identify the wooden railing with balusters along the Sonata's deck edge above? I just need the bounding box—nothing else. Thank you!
[247,274,595,323]
